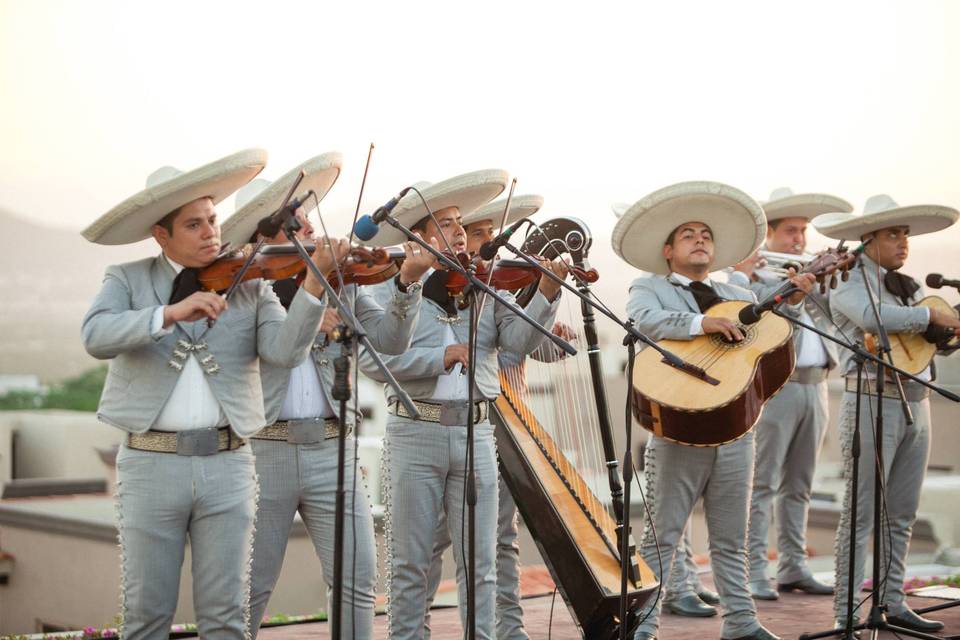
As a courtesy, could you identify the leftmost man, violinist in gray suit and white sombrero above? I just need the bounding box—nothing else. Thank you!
[82,149,333,640]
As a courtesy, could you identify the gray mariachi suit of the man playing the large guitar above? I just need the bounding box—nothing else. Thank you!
[627,275,760,638]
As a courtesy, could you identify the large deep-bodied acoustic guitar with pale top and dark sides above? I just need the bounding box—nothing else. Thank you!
[632,248,856,447]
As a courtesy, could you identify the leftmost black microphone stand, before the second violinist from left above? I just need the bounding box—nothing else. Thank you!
[270,210,420,640]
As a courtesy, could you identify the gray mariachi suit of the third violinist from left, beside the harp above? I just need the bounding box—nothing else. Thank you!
[361,276,558,639]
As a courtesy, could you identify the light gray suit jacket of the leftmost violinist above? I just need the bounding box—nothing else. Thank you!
[81,256,324,436]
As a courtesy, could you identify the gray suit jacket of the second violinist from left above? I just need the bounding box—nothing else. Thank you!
[260,280,421,425]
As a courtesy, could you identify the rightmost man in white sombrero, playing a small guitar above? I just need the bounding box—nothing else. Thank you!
[813,195,960,633]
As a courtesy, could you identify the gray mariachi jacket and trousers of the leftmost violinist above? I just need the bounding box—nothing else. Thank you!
[82,257,323,638]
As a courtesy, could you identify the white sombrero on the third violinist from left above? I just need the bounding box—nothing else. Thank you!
[366,169,509,247]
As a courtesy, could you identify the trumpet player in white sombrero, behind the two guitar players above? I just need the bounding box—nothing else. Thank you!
[730,189,853,600]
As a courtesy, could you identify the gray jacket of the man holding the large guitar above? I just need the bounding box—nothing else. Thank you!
[627,275,757,340]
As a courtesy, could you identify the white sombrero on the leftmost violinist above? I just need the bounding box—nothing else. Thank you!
[82,149,267,244]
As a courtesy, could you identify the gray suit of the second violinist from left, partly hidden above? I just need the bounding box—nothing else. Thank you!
[250,286,420,639]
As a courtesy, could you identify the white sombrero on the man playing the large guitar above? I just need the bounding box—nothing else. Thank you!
[613,181,767,275]
